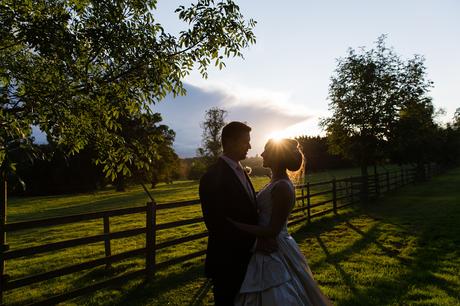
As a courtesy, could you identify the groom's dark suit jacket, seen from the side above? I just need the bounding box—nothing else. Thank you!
[200,158,257,282]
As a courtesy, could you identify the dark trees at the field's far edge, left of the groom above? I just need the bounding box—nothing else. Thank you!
[8,144,181,195]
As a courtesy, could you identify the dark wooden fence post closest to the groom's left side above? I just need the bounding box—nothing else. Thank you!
[145,200,156,281]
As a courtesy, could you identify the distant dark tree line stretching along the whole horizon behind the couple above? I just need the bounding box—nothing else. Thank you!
[9,118,460,195]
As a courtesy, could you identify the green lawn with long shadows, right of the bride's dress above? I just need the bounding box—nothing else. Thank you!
[295,169,460,305]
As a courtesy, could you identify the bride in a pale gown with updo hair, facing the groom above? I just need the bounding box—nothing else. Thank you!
[230,139,332,306]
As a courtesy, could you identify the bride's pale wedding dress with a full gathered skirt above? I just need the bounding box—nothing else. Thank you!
[235,180,332,306]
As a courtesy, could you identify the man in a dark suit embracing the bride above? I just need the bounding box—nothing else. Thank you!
[200,121,277,306]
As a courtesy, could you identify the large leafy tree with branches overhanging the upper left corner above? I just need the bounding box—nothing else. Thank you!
[0,0,255,179]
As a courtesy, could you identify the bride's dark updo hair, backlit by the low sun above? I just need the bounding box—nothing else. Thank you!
[267,138,304,180]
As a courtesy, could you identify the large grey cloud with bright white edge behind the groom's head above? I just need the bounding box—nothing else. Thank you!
[152,83,315,157]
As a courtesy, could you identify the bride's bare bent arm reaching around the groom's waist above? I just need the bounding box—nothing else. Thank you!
[230,181,292,238]
